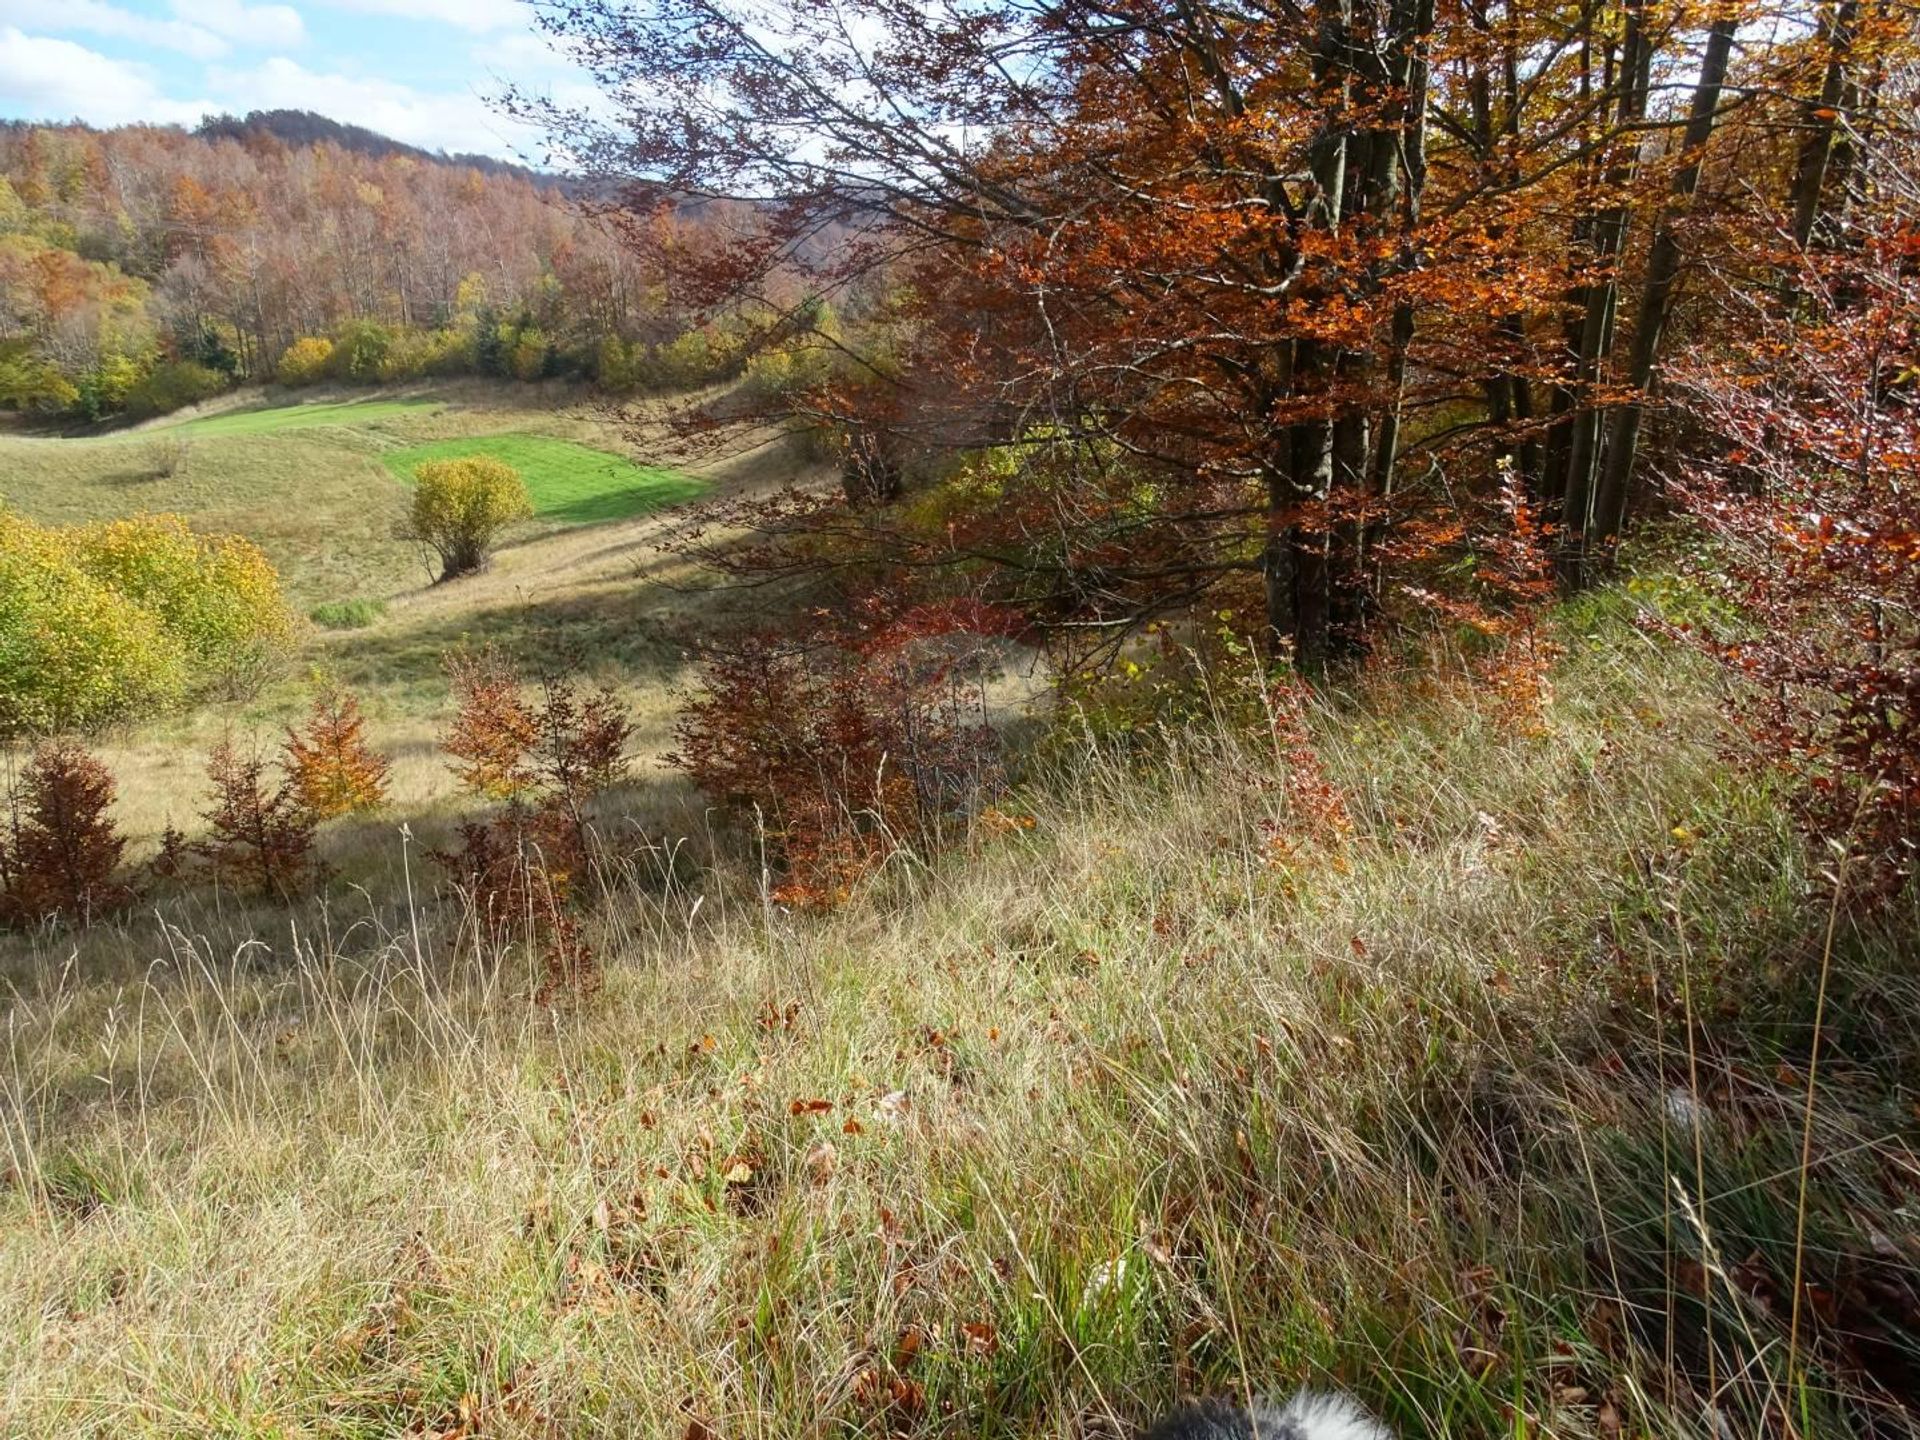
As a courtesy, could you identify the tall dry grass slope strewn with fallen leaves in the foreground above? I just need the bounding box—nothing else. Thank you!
[0,618,1920,1440]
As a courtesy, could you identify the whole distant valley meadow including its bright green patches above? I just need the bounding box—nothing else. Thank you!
[0,382,787,856]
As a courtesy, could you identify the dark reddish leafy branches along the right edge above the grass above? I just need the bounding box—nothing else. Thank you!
[1674,214,1920,899]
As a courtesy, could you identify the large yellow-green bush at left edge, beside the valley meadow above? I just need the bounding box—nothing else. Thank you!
[0,511,296,735]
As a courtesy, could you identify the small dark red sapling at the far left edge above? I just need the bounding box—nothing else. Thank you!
[0,739,131,924]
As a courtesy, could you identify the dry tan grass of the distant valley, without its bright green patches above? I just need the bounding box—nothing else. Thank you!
[0,382,818,874]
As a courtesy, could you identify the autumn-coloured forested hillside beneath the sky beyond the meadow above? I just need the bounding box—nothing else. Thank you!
[0,111,733,419]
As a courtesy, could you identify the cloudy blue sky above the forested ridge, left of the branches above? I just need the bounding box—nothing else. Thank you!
[0,0,589,163]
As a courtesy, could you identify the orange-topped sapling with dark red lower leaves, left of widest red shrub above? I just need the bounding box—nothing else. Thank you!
[436,651,634,1004]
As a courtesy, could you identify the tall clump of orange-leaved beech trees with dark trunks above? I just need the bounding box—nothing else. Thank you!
[528,0,1912,666]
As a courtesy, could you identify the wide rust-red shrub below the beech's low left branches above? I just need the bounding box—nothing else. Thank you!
[674,605,998,906]
